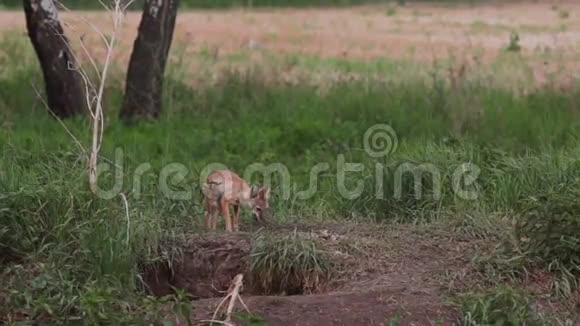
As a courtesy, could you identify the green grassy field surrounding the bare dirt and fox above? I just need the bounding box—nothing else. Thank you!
[0,2,580,325]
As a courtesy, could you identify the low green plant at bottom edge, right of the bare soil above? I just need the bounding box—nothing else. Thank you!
[460,286,544,326]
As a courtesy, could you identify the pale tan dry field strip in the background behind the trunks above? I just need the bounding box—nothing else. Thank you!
[0,1,580,83]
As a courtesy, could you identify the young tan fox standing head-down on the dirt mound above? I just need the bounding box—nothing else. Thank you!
[202,170,271,232]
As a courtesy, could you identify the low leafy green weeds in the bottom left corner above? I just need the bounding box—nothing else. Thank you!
[0,263,192,325]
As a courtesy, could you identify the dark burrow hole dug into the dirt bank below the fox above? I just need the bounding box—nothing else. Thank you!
[142,233,330,299]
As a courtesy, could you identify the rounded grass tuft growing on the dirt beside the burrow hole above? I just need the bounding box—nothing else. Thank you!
[250,232,330,295]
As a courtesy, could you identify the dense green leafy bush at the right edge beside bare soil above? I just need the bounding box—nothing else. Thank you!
[480,185,580,297]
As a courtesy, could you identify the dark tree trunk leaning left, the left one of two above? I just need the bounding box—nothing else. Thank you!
[23,0,87,118]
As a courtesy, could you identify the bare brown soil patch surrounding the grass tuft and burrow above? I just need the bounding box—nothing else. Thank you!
[145,224,486,325]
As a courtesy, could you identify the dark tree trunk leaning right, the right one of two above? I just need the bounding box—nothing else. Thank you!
[120,0,179,121]
